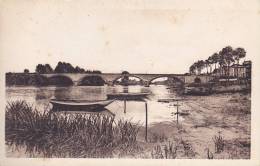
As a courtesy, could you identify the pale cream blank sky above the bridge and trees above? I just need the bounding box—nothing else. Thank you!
[0,0,260,74]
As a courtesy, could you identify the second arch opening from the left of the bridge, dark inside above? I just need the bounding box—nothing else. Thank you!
[77,75,107,86]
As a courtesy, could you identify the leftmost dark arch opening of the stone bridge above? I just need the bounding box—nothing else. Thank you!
[48,75,73,86]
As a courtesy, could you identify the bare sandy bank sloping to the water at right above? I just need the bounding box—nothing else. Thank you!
[137,92,251,159]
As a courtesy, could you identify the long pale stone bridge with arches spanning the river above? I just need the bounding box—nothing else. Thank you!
[41,73,213,86]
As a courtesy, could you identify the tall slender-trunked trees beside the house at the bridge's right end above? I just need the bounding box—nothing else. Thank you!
[189,46,246,77]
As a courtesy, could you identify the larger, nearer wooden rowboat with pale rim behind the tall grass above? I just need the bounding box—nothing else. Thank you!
[50,99,114,111]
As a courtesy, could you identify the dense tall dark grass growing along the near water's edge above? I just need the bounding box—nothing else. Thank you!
[5,101,139,158]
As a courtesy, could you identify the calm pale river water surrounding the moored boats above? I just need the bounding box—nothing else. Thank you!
[6,85,183,125]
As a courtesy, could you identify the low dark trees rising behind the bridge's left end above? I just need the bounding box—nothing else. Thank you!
[31,62,101,74]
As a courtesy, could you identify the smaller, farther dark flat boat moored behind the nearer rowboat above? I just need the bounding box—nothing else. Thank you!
[107,93,150,100]
